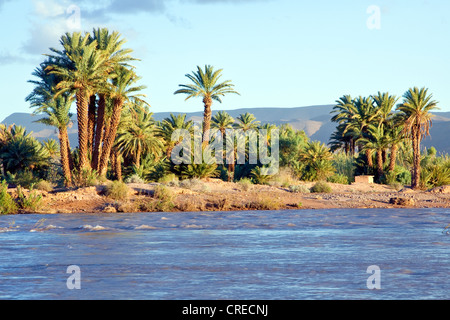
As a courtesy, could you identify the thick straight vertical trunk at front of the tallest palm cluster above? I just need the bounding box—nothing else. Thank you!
[76,89,89,170]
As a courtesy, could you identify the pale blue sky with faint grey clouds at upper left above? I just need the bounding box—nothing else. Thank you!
[0,0,450,121]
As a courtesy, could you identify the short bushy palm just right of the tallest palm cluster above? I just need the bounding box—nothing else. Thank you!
[117,104,164,168]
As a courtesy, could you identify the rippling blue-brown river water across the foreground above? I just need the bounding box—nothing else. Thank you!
[0,209,450,300]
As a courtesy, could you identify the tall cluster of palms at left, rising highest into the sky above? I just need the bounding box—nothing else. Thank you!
[26,28,146,186]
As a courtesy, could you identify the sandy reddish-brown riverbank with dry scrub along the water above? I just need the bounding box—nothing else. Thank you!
[10,179,450,214]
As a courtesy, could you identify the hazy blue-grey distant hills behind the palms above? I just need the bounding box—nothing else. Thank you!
[2,105,450,154]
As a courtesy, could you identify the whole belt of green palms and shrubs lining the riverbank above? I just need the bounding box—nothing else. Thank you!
[0,29,450,188]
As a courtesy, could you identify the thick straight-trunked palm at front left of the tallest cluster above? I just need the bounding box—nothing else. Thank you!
[47,32,111,169]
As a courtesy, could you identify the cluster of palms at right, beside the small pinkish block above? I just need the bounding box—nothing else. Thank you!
[330,87,437,188]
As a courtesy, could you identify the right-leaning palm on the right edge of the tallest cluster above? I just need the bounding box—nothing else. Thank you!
[98,67,146,176]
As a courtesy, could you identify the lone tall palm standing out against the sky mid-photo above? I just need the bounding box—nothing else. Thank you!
[174,65,239,141]
